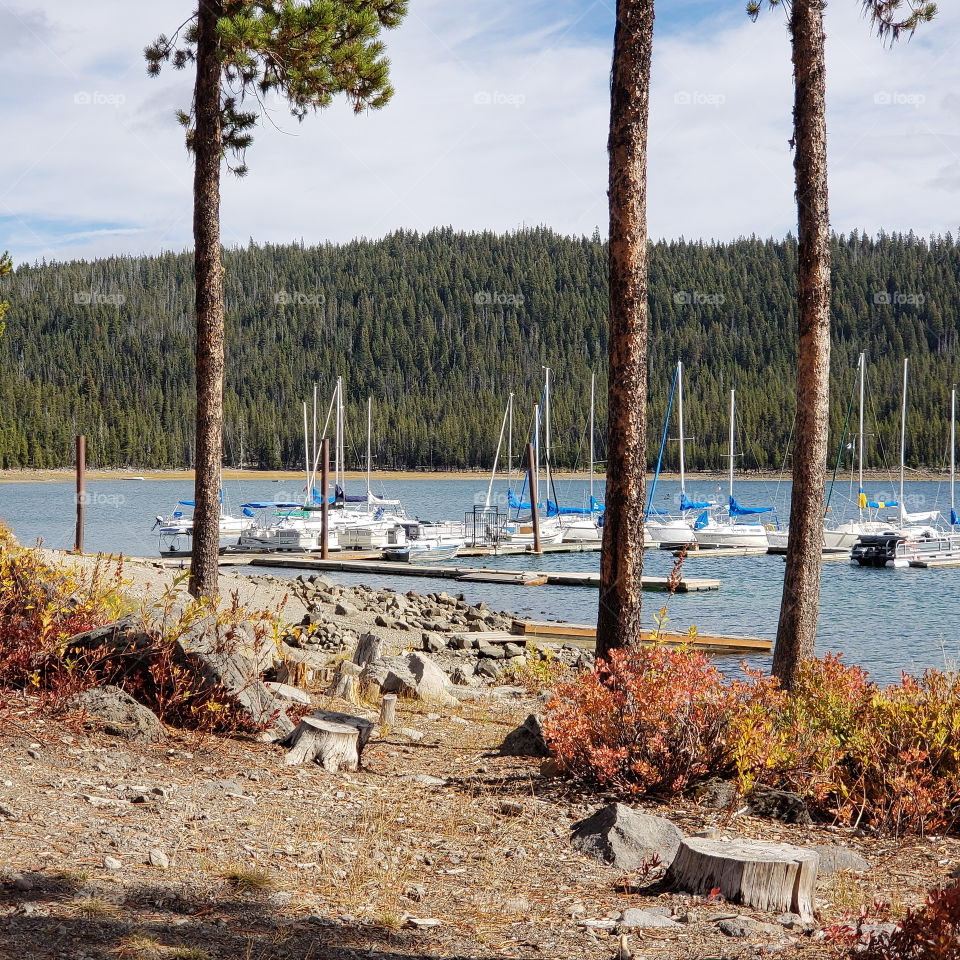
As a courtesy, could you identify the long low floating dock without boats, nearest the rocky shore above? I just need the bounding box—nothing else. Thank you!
[242,554,720,593]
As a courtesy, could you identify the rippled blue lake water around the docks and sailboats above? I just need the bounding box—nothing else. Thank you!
[0,477,960,682]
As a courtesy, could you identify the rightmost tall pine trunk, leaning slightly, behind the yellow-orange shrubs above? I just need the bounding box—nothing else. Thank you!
[773,0,830,688]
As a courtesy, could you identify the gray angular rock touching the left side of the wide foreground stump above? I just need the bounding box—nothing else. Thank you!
[570,803,683,870]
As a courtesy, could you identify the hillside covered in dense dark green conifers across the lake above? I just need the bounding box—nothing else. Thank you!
[0,229,960,470]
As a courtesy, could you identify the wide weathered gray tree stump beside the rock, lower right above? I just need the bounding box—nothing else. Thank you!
[666,837,820,920]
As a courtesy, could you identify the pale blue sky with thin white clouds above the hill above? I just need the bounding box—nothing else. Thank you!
[0,0,960,263]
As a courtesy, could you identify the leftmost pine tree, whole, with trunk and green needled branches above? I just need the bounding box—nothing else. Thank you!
[144,0,406,596]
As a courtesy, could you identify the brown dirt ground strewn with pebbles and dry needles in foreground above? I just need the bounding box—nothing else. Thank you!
[0,561,960,960]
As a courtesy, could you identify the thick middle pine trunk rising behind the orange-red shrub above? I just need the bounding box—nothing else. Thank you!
[597,0,653,657]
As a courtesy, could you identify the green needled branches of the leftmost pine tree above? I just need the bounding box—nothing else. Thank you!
[144,0,407,176]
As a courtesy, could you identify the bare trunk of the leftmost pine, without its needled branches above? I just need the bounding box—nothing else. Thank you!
[190,0,224,597]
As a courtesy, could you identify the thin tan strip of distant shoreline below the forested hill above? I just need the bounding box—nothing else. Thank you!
[0,467,950,485]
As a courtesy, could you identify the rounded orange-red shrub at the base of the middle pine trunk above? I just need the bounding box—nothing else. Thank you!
[544,645,764,796]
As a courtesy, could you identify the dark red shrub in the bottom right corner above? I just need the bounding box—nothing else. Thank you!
[849,884,960,960]
